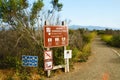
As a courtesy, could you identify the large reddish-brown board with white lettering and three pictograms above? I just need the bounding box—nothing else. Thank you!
[44,26,68,48]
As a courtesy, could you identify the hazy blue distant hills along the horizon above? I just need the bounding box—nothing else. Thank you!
[69,25,120,30]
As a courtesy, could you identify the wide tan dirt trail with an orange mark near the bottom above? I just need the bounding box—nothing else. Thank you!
[48,38,120,80]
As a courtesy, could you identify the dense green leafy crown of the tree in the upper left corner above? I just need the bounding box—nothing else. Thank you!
[0,0,44,28]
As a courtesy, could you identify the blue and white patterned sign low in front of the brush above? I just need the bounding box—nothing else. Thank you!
[22,55,38,67]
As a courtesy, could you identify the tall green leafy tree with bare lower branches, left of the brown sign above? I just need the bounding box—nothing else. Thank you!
[0,0,62,45]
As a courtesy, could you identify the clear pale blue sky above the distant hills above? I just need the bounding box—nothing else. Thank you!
[44,0,120,28]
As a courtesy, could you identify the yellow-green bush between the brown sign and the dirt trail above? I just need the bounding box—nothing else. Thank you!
[69,29,97,63]
